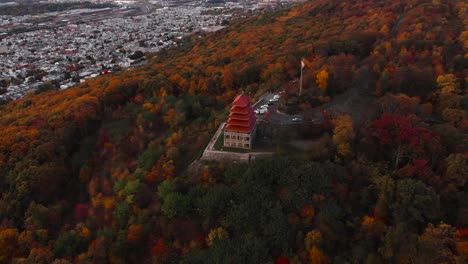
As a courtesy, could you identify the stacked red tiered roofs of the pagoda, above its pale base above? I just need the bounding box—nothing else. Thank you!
[224,94,256,133]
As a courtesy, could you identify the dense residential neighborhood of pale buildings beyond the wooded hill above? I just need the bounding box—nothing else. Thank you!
[0,2,288,101]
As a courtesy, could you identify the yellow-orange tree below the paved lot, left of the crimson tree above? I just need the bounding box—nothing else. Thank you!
[333,115,355,157]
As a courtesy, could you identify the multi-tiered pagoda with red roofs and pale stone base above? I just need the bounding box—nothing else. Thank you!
[224,94,256,149]
